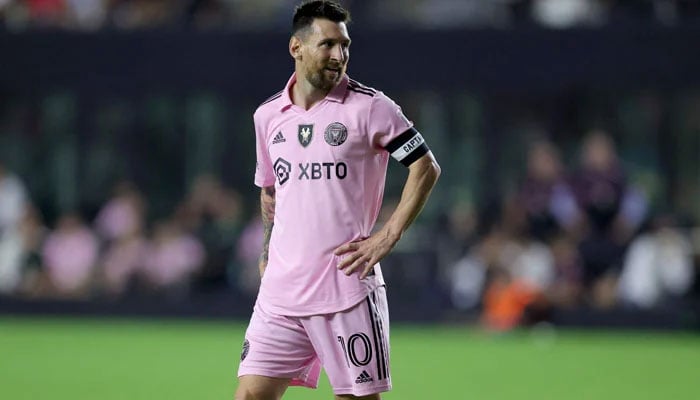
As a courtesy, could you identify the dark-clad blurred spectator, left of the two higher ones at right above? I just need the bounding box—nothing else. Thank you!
[517,140,581,241]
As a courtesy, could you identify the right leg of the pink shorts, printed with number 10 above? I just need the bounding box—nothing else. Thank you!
[301,287,391,398]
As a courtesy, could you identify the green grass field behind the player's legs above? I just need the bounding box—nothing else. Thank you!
[0,317,700,400]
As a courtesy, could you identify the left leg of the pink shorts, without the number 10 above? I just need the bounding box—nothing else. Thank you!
[238,304,321,388]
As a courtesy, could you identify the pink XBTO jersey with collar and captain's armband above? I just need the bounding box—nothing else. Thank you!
[254,75,428,316]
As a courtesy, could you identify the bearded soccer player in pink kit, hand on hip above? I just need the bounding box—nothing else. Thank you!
[236,0,440,400]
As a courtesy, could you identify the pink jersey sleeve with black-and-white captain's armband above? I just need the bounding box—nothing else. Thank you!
[369,92,430,166]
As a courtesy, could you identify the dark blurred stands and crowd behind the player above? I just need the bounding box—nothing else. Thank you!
[0,0,700,332]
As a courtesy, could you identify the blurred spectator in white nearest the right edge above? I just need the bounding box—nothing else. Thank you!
[618,216,694,308]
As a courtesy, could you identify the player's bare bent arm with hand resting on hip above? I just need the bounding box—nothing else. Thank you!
[335,152,440,279]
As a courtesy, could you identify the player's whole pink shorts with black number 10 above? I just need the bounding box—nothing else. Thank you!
[238,286,391,396]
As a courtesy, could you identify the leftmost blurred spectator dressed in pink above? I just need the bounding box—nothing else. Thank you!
[42,213,99,298]
